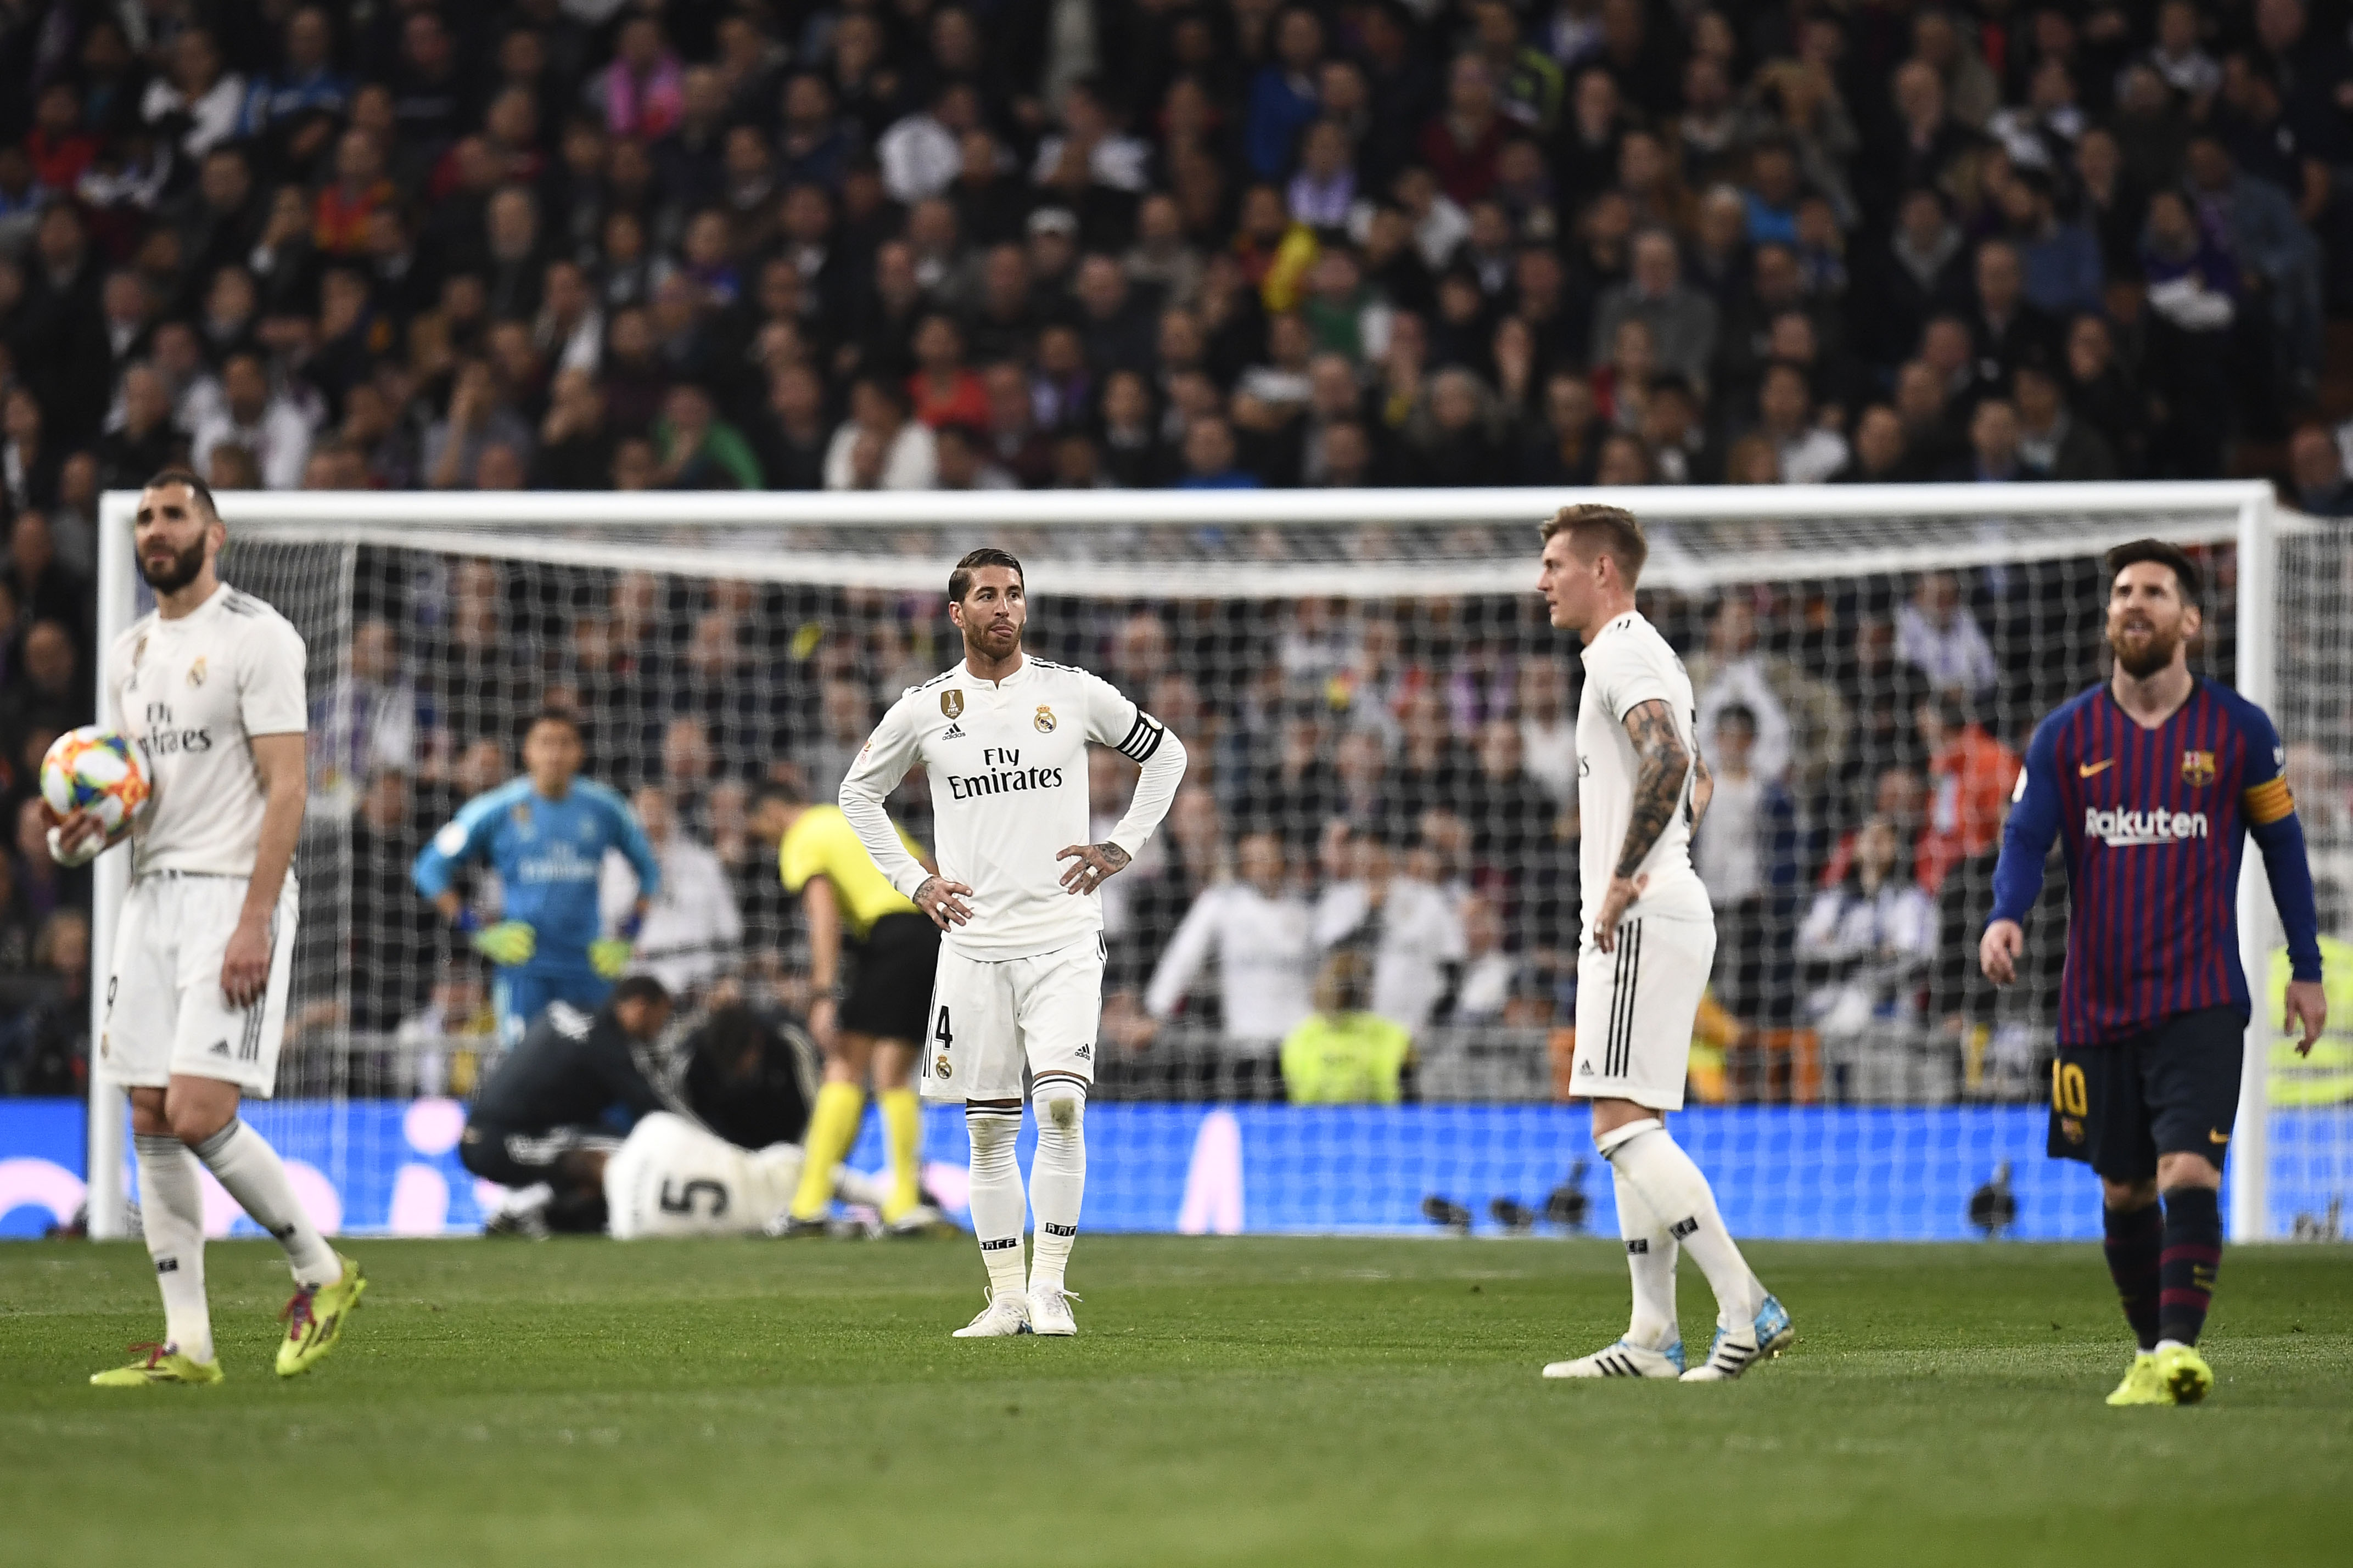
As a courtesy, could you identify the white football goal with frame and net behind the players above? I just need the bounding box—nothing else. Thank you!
[92,484,2353,1239]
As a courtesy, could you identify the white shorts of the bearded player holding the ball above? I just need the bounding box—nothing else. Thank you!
[99,872,299,1100]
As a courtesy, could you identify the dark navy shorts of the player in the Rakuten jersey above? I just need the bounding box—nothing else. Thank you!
[2047,1006,2247,1183]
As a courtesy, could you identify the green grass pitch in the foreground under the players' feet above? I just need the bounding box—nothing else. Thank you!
[0,1237,2353,1568]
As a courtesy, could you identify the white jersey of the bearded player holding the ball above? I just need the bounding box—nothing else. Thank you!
[106,588,311,877]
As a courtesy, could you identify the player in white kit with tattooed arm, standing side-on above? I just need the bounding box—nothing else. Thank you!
[1537,505,1795,1382]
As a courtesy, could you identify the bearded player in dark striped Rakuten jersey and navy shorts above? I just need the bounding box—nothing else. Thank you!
[1979,538,2327,1406]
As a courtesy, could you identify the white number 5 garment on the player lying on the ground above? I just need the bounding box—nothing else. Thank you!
[605,1110,803,1241]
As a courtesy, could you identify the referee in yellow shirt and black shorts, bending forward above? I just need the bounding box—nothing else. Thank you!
[770,788,944,1237]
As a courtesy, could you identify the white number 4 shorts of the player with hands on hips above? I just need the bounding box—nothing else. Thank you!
[918,933,1103,1100]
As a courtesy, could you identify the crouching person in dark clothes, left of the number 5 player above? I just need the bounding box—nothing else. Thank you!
[456,976,671,1237]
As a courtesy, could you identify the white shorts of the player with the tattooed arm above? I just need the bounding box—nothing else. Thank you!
[1570,914,1715,1110]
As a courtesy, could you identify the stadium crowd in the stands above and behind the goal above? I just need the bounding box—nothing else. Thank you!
[0,0,2353,1091]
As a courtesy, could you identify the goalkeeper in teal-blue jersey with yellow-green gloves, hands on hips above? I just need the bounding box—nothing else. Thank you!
[414,712,661,1046]
